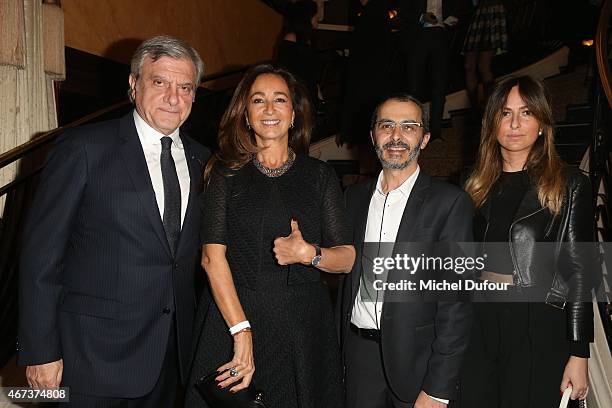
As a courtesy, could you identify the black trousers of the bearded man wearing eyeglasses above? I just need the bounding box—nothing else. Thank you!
[344,331,414,408]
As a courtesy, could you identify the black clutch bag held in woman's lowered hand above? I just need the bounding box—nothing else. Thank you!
[195,371,266,408]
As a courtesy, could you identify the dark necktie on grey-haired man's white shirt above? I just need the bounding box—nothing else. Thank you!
[160,136,181,255]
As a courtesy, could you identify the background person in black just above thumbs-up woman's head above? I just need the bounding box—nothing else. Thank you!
[276,0,321,107]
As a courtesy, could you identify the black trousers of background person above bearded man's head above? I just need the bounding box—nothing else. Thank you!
[404,27,450,137]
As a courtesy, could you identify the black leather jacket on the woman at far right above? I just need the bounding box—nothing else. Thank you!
[474,168,597,342]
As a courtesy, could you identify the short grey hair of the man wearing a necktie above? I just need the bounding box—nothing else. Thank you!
[128,35,204,102]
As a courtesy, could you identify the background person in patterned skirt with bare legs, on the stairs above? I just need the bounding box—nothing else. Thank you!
[462,0,508,116]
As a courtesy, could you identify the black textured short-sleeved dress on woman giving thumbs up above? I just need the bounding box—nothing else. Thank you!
[186,155,351,408]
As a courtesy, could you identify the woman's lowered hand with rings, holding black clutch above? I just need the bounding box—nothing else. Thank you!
[216,331,255,392]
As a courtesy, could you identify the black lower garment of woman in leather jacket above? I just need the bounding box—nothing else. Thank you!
[460,302,569,408]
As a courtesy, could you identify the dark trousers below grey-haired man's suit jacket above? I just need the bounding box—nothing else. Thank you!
[64,327,179,408]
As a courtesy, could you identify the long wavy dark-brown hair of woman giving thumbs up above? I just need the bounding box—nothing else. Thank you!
[204,64,313,180]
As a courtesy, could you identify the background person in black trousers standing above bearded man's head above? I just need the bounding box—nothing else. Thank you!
[398,0,460,140]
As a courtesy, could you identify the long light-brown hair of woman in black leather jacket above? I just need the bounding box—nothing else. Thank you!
[465,76,565,214]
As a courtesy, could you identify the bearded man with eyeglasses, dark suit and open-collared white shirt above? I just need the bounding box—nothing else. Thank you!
[338,94,473,408]
